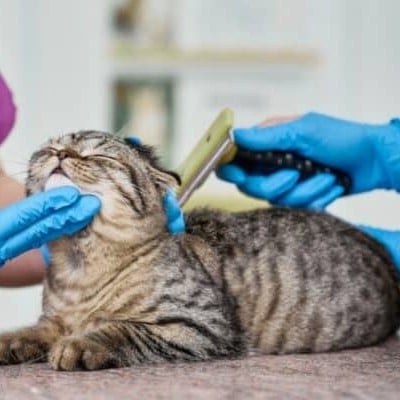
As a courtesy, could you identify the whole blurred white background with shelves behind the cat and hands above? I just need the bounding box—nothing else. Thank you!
[0,0,400,330]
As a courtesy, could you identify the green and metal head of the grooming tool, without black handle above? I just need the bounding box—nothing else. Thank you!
[177,108,236,206]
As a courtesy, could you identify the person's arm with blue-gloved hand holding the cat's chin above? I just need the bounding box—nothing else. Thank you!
[0,177,100,286]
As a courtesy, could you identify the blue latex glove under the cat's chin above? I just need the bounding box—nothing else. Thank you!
[0,186,101,266]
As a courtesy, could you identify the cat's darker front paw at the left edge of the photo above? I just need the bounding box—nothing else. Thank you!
[0,334,47,365]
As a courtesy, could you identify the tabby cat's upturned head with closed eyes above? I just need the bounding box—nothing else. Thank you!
[26,131,179,236]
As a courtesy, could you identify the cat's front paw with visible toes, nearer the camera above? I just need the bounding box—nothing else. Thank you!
[48,337,117,371]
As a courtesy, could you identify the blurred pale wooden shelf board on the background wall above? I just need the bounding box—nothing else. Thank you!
[112,44,320,77]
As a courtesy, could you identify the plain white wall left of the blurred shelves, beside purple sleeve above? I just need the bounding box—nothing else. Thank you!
[0,0,110,170]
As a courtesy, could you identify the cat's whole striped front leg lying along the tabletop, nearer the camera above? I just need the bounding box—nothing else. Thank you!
[49,320,238,371]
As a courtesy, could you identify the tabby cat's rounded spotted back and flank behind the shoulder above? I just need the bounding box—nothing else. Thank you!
[187,208,400,352]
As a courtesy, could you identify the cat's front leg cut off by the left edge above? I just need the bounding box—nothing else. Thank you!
[0,317,62,365]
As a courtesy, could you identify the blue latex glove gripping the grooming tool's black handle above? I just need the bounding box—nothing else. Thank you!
[217,113,400,209]
